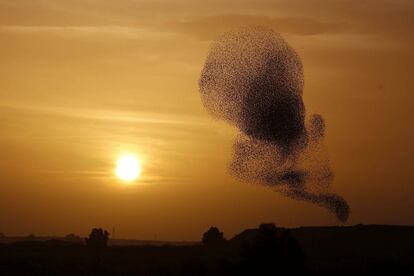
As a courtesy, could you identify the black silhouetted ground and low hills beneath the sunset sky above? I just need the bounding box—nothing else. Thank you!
[0,225,414,275]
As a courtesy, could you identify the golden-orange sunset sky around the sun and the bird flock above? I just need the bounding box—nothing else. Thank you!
[0,0,414,240]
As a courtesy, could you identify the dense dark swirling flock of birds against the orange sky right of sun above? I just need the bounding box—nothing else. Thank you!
[199,27,349,222]
